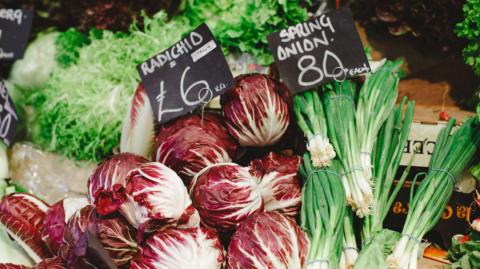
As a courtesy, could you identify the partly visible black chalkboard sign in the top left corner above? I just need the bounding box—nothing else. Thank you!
[0,8,33,60]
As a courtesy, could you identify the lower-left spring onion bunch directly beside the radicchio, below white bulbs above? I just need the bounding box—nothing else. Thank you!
[300,153,347,269]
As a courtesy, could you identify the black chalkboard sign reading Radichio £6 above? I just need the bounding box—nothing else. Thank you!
[137,24,233,123]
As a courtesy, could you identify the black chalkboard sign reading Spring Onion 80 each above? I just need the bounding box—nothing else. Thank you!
[268,7,370,93]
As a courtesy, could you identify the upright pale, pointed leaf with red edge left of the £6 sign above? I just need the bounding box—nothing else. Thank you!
[120,84,155,157]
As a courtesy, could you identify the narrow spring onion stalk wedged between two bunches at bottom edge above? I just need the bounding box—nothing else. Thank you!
[340,209,358,269]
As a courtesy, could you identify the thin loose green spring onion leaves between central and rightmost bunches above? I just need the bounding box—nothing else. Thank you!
[362,97,415,241]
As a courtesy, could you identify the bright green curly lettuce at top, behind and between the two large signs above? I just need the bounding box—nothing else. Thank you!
[183,0,307,65]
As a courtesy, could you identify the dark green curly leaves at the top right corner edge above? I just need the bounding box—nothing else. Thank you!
[455,0,480,75]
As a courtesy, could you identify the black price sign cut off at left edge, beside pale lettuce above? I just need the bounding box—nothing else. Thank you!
[0,81,18,147]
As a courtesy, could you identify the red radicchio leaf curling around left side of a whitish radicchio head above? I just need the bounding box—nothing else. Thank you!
[88,153,148,215]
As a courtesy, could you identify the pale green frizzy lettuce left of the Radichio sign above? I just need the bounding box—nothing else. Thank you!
[28,12,191,161]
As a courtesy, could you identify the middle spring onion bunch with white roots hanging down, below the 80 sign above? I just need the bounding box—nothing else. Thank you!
[323,81,373,217]
